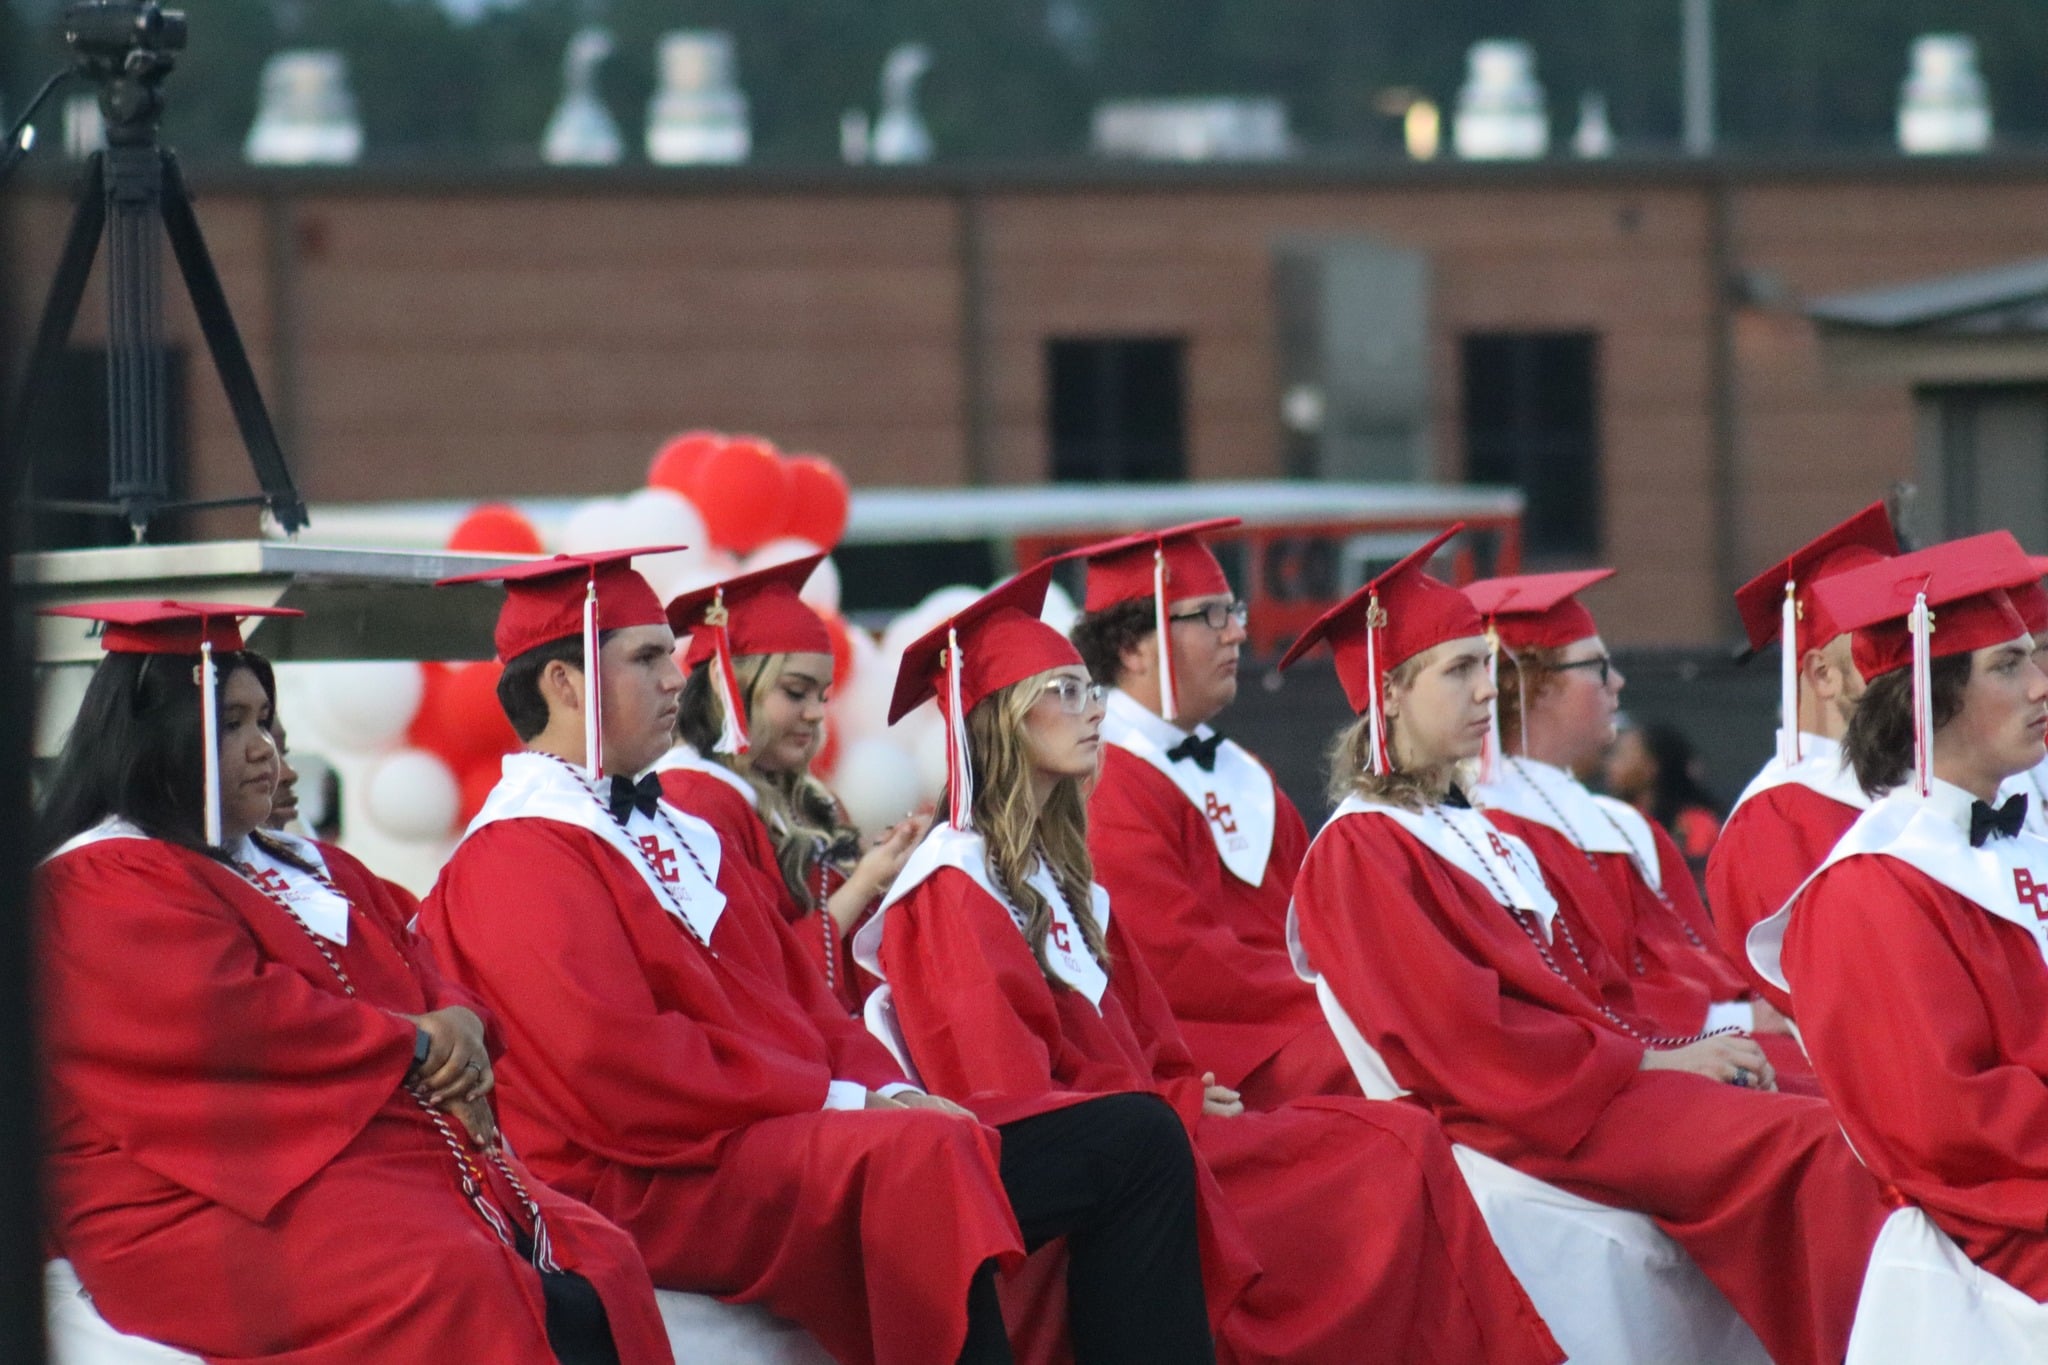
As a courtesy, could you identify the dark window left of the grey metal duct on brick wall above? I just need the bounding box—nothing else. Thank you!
[1047,338,1188,483]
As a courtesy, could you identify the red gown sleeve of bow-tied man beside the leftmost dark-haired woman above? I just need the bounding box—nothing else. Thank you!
[422,821,858,1166]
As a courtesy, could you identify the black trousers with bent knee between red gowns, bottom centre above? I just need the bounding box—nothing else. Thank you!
[961,1095,1217,1365]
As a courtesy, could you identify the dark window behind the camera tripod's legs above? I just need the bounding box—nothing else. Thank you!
[23,346,190,551]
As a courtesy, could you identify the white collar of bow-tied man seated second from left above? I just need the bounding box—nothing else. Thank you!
[463,753,725,943]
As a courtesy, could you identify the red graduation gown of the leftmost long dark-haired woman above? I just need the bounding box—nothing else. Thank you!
[41,839,670,1365]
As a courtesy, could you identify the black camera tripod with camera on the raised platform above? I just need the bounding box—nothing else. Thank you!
[8,0,307,542]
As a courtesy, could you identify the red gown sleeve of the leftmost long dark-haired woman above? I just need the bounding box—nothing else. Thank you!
[41,839,414,1220]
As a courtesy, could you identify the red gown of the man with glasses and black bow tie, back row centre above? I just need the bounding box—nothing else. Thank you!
[1087,745,1358,1109]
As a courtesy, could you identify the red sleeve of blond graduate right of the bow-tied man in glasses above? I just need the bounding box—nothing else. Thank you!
[1294,817,1642,1154]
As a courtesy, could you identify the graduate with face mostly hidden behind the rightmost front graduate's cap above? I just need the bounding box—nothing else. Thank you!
[1706,503,1898,1017]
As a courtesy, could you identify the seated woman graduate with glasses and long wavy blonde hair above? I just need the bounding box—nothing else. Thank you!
[854,565,1561,1365]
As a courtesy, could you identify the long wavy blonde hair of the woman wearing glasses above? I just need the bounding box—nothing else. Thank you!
[938,669,1110,990]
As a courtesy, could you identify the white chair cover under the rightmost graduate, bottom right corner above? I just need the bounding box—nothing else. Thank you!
[1845,1207,2048,1365]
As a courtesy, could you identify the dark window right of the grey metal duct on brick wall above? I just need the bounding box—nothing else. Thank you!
[1462,332,1599,557]
